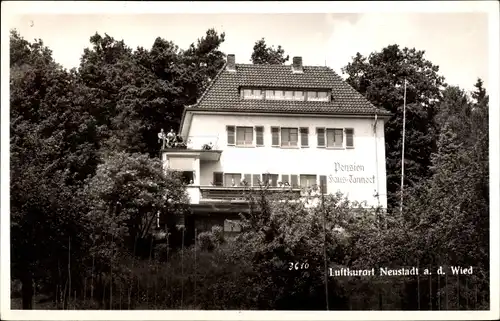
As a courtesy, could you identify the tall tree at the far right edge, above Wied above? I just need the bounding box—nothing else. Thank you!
[430,82,489,269]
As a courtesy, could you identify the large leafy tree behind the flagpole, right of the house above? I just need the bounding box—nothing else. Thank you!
[342,45,446,206]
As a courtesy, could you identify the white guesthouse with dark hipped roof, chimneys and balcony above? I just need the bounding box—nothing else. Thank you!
[162,55,390,234]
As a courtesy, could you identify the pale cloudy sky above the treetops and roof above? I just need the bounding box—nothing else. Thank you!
[2,3,489,90]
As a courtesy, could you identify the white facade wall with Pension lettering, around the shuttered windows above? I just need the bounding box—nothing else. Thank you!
[188,114,387,207]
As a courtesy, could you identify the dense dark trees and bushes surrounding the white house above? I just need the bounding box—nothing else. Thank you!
[10,30,489,310]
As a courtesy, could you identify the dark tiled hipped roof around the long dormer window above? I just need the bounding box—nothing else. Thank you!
[187,64,389,115]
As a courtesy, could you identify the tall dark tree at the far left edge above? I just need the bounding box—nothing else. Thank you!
[10,31,98,309]
